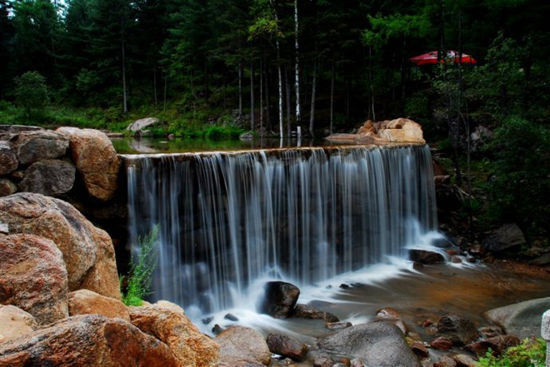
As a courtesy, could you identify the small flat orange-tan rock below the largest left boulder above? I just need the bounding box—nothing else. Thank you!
[69,289,130,321]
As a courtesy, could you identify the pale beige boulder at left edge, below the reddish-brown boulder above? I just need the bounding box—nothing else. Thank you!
[0,305,38,344]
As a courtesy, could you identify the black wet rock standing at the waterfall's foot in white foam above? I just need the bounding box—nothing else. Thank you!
[260,281,300,319]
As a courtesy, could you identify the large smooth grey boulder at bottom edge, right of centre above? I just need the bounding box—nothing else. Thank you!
[317,321,420,367]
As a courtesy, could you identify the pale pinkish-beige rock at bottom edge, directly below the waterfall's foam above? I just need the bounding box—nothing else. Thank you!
[215,326,271,366]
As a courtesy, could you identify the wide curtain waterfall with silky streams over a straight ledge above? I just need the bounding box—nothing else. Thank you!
[125,146,437,312]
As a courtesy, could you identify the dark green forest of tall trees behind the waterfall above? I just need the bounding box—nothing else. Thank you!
[0,0,550,246]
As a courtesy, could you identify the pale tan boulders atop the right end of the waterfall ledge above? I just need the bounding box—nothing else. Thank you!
[327,118,426,144]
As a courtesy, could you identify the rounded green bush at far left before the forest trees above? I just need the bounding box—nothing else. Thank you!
[14,71,48,118]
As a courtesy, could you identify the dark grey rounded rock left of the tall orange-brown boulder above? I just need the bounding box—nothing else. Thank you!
[19,159,76,196]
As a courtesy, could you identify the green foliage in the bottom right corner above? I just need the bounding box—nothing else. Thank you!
[478,338,546,367]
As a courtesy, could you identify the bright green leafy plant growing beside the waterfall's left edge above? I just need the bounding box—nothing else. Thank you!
[121,226,159,306]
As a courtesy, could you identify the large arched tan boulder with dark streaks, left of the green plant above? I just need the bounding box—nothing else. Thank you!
[0,193,120,299]
